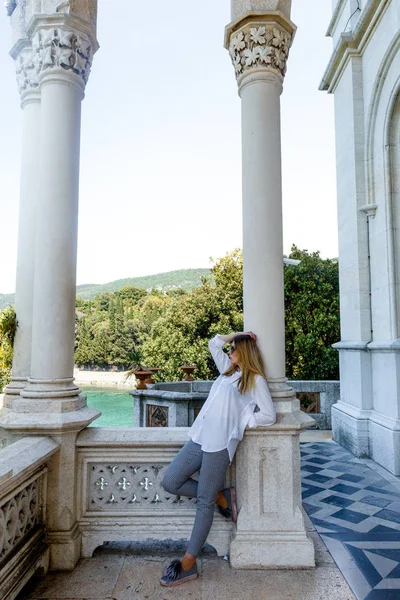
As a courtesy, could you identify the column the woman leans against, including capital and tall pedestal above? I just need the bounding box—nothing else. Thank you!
[225,0,315,569]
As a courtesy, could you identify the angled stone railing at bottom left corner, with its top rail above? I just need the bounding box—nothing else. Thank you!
[0,437,58,600]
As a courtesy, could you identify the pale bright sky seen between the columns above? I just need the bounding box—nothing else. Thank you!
[0,0,338,293]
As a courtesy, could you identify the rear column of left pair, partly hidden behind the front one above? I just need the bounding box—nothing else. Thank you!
[4,41,40,408]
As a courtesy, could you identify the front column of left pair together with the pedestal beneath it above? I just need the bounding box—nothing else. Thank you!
[0,8,100,570]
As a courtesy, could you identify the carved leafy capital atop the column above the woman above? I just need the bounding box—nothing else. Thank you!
[225,12,295,88]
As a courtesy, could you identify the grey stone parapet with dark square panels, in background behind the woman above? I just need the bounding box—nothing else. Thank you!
[131,380,340,429]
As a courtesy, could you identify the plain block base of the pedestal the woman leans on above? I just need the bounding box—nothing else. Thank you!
[230,531,315,569]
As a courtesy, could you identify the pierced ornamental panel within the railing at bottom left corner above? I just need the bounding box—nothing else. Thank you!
[0,480,41,565]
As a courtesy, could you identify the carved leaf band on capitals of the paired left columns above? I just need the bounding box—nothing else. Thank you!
[17,28,93,92]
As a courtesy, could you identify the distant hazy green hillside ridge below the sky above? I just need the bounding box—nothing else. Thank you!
[0,269,210,310]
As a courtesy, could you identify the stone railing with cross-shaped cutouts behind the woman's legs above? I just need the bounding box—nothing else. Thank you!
[77,427,234,557]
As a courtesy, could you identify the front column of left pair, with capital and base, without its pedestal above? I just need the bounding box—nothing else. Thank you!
[3,15,99,426]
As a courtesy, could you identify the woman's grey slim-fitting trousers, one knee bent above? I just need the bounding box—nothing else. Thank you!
[162,440,230,556]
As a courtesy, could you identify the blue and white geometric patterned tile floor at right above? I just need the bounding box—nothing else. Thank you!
[301,442,400,600]
